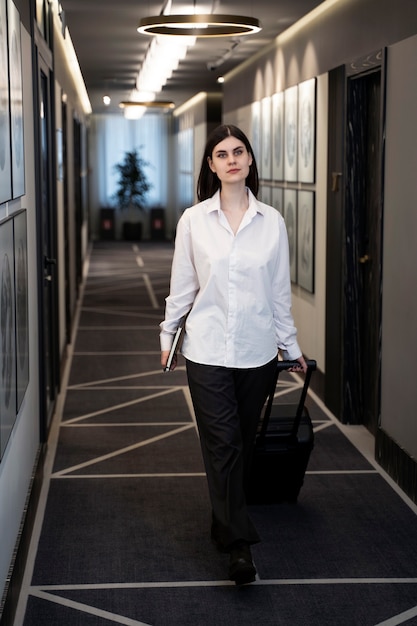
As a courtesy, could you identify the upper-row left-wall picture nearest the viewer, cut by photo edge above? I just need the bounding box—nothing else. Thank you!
[0,0,12,204]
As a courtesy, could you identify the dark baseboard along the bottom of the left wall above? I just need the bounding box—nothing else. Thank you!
[0,444,47,626]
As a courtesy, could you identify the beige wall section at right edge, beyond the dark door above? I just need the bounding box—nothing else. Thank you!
[381,36,417,459]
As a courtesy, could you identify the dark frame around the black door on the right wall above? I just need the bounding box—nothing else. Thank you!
[324,51,385,432]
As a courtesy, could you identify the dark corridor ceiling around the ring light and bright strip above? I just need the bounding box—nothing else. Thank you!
[62,0,322,113]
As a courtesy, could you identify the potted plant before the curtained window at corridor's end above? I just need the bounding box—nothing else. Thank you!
[115,149,151,241]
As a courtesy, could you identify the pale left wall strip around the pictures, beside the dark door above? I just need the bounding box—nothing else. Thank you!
[0,27,39,604]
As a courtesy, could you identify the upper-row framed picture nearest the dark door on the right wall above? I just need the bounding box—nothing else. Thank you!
[298,78,316,183]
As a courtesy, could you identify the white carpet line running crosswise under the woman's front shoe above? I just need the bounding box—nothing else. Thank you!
[30,578,417,593]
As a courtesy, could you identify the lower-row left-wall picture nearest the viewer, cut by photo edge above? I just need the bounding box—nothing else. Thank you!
[0,218,16,458]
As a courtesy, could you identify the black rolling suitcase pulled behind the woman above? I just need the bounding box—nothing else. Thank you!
[246,360,316,504]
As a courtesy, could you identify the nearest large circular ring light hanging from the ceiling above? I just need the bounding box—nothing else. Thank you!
[137,14,262,37]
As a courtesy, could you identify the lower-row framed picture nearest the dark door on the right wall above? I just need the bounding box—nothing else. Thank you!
[297,190,315,293]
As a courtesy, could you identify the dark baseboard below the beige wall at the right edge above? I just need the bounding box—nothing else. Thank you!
[375,428,417,503]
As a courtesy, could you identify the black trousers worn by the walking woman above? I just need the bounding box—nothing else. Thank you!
[186,359,277,549]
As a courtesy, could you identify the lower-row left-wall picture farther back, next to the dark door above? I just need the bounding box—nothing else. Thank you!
[13,209,29,413]
